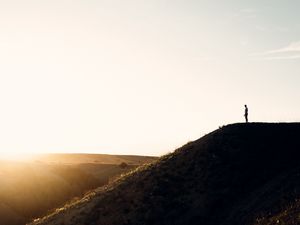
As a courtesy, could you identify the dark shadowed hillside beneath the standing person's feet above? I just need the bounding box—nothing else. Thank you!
[34,123,300,225]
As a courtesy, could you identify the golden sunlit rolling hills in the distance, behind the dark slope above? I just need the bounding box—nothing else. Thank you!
[0,154,155,225]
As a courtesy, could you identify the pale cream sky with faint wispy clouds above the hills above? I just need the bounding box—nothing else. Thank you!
[0,0,300,156]
